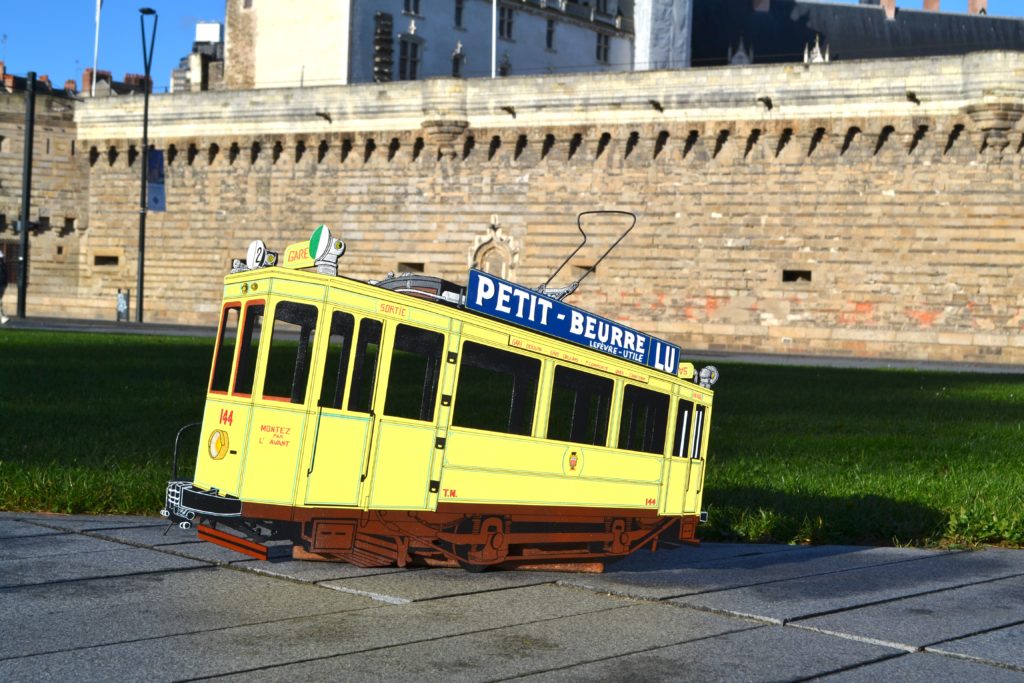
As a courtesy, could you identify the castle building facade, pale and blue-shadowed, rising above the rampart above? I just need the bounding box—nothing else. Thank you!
[225,0,638,88]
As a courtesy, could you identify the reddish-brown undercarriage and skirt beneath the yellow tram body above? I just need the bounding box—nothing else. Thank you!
[215,503,698,569]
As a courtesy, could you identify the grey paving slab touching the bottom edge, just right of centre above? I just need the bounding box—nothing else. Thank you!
[513,626,901,683]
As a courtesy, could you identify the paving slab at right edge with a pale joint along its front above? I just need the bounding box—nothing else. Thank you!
[793,577,1024,651]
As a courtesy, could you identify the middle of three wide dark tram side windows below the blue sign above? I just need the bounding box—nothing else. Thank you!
[548,366,614,445]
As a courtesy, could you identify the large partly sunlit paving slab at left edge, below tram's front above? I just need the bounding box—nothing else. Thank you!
[0,567,378,659]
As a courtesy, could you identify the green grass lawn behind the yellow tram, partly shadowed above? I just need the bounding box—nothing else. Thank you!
[0,331,1024,545]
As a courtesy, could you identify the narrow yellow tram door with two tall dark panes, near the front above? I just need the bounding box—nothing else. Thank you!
[305,309,383,506]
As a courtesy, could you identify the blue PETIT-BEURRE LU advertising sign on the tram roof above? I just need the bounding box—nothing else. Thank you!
[466,269,680,375]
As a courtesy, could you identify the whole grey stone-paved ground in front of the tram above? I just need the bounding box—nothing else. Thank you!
[0,513,1024,683]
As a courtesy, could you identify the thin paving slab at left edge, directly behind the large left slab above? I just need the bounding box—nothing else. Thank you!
[0,537,209,589]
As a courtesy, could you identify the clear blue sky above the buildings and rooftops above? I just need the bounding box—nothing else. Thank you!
[0,0,1024,92]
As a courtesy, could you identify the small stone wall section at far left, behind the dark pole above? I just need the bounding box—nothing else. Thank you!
[0,91,88,315]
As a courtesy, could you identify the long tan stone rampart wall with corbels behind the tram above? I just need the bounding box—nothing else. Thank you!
[22,52,1024,364]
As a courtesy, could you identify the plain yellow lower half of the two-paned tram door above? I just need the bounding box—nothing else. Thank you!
[304,411,370,505]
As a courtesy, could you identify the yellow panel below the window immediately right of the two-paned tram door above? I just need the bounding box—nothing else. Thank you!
[370,420,434,510]
